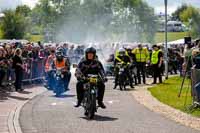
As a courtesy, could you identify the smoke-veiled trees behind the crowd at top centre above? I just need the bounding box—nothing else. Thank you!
[31,0,156,42]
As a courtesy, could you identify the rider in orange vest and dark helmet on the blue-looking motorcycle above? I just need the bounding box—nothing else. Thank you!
[52,48,71,90]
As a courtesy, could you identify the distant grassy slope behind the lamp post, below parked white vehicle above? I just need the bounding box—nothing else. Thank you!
[155,32,188,43]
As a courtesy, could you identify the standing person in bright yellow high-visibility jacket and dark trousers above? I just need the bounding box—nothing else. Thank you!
[132,44,149,84]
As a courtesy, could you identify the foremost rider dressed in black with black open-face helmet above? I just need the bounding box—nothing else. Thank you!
[75,47,107,109]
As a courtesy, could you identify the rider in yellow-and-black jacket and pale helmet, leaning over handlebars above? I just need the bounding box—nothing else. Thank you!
[113,48,134,89]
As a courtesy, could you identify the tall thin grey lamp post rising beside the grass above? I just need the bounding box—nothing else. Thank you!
[164,0,168,79]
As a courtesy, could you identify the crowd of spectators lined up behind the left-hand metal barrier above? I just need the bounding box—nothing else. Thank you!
[0,42,84,91]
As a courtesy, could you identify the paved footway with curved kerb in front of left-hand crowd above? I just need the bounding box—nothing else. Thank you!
[0,86,45,133]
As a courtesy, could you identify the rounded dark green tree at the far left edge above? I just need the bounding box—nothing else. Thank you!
[1,10,26,39]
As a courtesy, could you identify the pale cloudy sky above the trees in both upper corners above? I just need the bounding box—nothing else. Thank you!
[0,0,200,14]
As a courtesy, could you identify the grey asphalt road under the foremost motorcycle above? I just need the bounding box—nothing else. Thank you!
[20,82,199,133]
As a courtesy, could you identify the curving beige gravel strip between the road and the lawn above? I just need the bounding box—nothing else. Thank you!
[131,85,200,130]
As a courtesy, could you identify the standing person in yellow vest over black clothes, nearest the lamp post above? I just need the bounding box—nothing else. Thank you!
[151,45,163,84]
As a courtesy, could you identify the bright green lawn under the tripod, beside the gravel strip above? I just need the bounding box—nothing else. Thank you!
[148,77,200,117]
